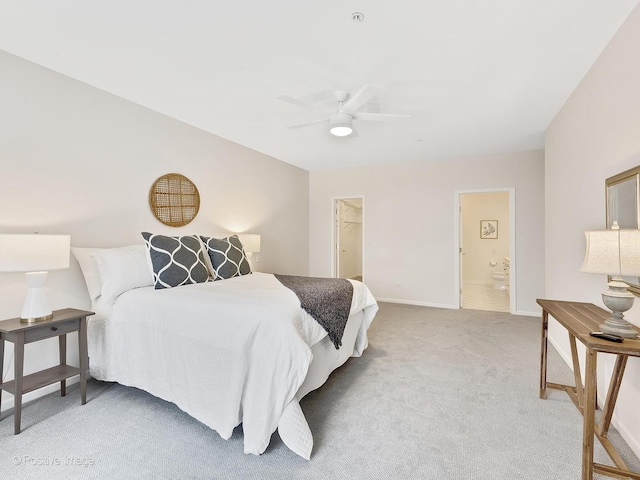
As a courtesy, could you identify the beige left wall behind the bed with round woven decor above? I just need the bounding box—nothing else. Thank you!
[0,51,309,408]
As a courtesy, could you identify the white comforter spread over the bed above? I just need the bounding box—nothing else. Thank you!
[89,273,377,454]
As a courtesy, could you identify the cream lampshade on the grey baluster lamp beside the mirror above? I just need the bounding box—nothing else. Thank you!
[580,229,640,277]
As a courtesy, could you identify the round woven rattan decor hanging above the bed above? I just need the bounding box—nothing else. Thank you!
[149,173,200,227]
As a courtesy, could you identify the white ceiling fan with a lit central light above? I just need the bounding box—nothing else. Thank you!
[278,85,410,137]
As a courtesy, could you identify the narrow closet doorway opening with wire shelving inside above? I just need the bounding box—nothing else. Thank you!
[333,197,364,281]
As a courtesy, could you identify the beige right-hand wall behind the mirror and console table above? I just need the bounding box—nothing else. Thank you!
[545,0,640,455]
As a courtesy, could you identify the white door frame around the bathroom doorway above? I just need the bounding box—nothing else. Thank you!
[453,187,518,314]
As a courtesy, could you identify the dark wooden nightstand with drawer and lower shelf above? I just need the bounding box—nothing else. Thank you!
[0,308,93,435]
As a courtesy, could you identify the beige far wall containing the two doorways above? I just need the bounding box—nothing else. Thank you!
[309,151,544,315]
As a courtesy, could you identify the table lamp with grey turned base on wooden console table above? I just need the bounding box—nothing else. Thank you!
[580,222,640,338]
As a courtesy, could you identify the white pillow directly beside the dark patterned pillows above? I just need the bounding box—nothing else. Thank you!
[91,245,153,303]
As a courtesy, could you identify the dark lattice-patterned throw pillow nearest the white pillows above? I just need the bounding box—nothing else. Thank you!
[142,232,209,289]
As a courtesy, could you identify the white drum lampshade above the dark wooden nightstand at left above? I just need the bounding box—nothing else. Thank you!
[0,234,71,272]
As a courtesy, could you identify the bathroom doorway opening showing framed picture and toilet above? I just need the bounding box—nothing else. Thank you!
[456,188,516,313]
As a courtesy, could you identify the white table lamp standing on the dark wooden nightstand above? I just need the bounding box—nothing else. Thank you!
[0,234,71,323]
